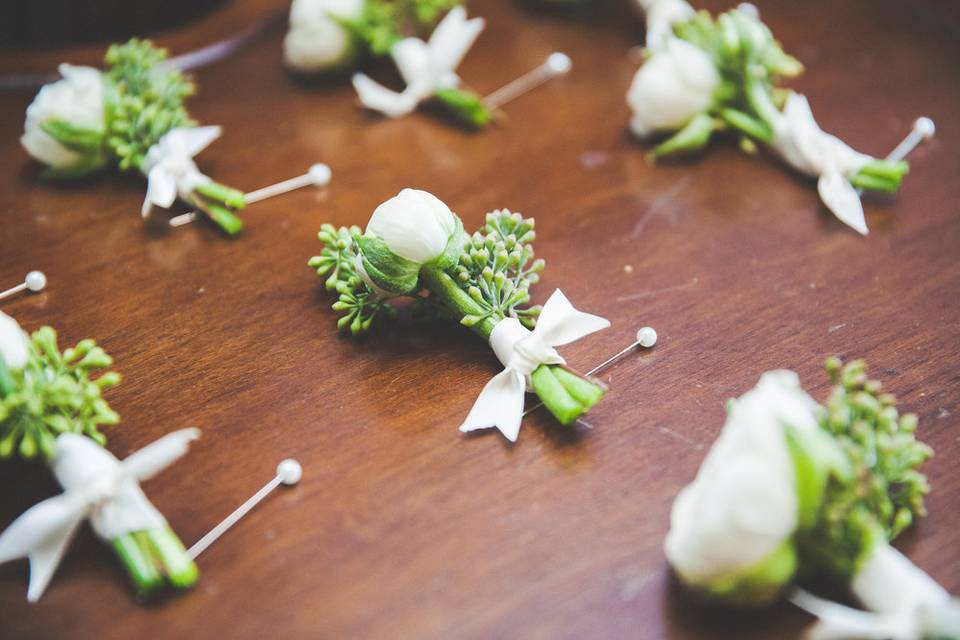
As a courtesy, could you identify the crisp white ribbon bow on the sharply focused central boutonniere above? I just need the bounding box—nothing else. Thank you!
[460,289,610,442]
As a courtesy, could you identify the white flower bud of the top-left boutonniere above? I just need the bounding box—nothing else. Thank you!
[20,64,106,170]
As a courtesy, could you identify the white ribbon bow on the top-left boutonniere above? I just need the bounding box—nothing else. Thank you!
[140,127,220,218]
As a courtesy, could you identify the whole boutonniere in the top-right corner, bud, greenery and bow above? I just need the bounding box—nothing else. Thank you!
[627,0,933,234]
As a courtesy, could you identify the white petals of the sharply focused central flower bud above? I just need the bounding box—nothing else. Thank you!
[366,189,457,264]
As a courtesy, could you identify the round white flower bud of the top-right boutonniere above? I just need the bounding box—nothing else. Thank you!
[627,37,720,137]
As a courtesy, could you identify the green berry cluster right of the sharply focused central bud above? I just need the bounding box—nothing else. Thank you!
[451,209,546,328]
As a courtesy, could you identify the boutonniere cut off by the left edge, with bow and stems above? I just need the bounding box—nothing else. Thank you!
[0,313,197,601]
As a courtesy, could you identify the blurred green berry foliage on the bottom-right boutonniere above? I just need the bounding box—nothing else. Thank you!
[798,358,933,581]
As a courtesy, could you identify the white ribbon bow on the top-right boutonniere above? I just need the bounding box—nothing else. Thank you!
[772,93,872,235]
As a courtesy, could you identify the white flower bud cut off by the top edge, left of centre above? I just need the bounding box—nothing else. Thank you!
[283,0,363,73]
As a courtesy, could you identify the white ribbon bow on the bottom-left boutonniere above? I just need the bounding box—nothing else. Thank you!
[0,429,200,602]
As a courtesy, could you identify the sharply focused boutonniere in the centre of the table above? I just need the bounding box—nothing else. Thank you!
[309,189,610,441]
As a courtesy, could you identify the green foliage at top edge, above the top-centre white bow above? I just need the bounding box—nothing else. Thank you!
[341,0,460,56]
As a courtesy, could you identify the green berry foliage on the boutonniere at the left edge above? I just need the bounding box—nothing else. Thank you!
[0,327,120,458]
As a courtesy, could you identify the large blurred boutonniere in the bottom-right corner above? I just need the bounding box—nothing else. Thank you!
[664,359,960,640]
